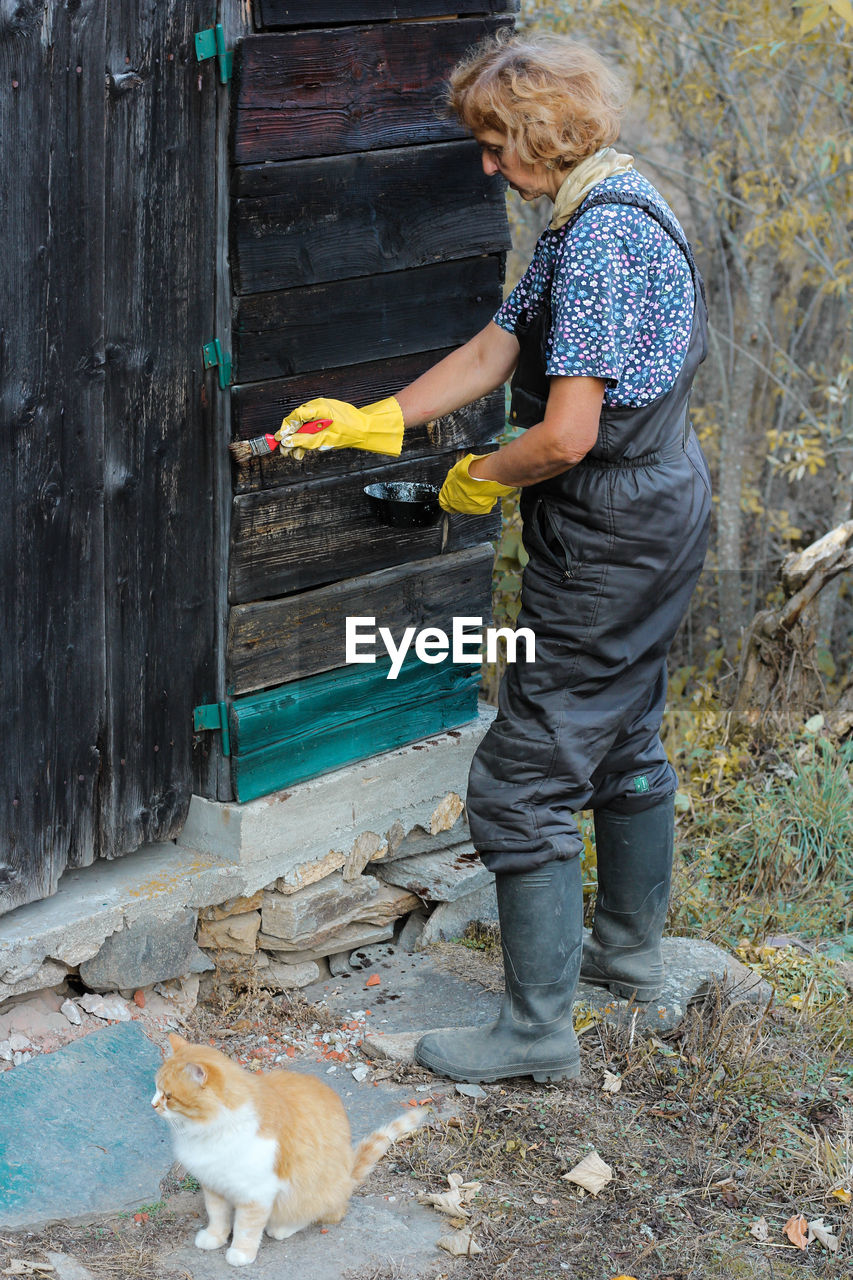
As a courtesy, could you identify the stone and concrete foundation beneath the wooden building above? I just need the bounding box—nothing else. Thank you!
[0,708,494,1029]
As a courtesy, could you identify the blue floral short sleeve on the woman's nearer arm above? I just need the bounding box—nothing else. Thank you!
[547,205,651,387]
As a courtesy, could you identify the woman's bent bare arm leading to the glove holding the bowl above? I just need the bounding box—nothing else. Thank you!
[468,373,605,488]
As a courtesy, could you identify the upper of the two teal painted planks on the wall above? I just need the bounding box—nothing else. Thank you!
[231,655,480,755]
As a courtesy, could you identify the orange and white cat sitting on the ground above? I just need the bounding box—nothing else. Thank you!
[151,1036,425,1267]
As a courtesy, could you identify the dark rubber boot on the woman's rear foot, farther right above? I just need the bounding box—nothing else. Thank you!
[580,797,675,1002]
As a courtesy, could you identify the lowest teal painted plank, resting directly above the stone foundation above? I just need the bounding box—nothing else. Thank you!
[232,676,479,803]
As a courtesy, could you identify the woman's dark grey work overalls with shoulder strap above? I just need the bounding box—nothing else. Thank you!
[467,189,711,872]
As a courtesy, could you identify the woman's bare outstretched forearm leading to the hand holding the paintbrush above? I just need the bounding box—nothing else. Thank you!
[394,321,519,426]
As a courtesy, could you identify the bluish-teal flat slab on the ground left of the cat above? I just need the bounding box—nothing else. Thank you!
[0,1023,174,1230]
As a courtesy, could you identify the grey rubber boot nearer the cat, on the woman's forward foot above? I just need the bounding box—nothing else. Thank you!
[415,858,583,1084]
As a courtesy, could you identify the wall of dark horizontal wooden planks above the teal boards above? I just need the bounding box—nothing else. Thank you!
[219,0,515,799]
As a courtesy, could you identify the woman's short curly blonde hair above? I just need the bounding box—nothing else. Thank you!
[447,32,626,168]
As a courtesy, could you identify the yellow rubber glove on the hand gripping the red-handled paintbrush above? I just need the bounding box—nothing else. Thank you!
[275,396,403,458]
